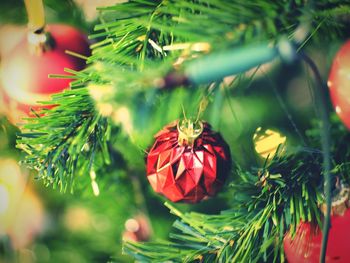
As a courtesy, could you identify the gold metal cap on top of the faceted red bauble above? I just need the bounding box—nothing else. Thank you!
[177,119,203,146]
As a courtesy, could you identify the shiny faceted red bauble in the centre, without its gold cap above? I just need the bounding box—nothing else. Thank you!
[147,122,231,203]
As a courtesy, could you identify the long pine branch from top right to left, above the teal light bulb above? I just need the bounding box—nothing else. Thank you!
[13,0,349,200]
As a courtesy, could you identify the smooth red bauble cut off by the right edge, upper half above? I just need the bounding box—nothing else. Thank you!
[328,40,350,129]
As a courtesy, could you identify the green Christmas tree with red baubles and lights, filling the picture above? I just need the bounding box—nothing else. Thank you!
[0,0,350,262]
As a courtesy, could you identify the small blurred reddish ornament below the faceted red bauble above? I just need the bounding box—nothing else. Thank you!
[123,214,152,242]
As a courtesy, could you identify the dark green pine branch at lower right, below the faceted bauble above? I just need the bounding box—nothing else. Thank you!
[125,147,323,262]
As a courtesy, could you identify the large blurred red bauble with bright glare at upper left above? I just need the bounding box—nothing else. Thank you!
[1,25,90,122]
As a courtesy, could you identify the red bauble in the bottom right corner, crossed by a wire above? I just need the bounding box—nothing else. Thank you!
[284,209,350,263]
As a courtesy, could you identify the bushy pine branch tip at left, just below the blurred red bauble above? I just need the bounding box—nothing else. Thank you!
[17,88,110,191]
